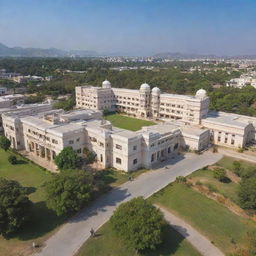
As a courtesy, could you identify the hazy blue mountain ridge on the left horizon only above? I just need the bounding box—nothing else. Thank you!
[0,43,99,57]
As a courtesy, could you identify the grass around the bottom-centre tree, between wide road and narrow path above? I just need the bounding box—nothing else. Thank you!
[76,222,200,256]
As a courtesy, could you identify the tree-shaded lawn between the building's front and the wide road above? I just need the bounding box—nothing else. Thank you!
[0,149,150,256]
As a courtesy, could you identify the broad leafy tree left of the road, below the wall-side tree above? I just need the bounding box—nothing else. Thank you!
[45,171,93,215]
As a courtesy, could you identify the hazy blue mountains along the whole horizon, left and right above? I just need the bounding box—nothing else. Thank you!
[0,43,256,59]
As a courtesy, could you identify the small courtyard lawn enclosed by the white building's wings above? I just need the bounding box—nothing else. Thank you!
[104,114,155,131]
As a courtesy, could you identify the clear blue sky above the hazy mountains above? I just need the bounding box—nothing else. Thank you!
[0,0,256,55]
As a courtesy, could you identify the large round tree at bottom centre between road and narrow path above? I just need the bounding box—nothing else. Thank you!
[110,197,165,250]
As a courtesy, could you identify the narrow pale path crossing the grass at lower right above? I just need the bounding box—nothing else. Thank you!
[157,206,224,256]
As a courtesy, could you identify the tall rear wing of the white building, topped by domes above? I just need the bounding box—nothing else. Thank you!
[76,80,209,124]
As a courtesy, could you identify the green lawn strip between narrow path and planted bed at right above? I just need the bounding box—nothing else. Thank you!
[150,183,256,254]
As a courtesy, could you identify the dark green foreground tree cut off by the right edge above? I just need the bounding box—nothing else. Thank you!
[238,177,256,209]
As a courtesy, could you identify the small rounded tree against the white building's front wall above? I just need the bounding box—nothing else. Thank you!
[55,147,82,170]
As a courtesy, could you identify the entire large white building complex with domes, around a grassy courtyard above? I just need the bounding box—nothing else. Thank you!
[2,81,256,171]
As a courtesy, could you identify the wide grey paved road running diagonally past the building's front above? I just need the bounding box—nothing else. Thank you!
[36,152,222,256]
